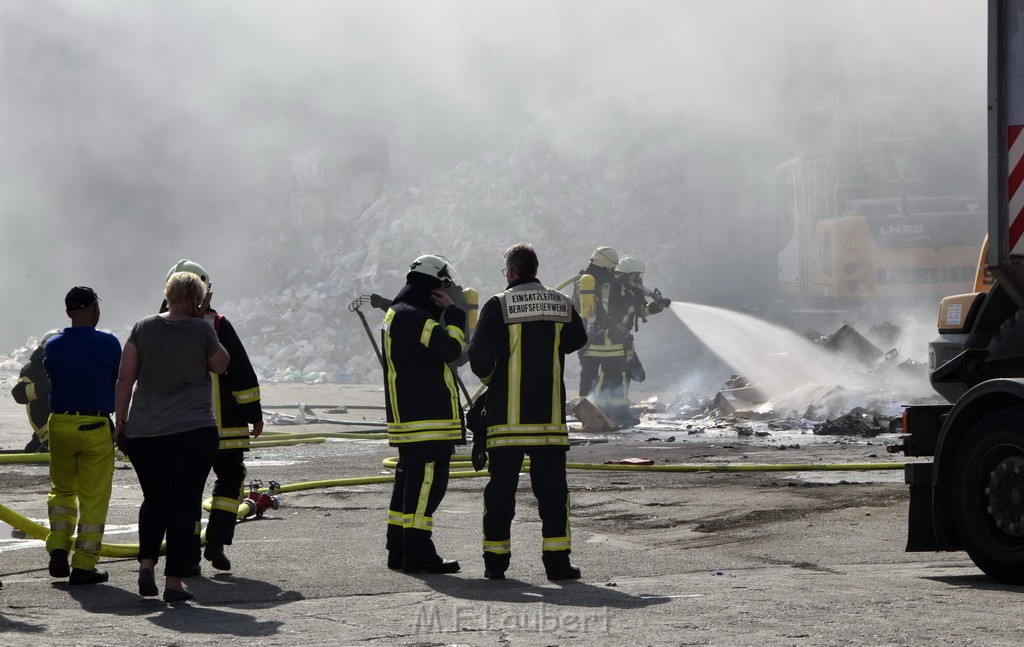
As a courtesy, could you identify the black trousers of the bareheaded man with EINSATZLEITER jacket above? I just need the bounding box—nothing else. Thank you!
[483,447,571,570]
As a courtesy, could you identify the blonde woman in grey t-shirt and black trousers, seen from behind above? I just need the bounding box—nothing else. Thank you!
[115,272,229,602]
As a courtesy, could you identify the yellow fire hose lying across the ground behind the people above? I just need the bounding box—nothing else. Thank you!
[0,440,905,558]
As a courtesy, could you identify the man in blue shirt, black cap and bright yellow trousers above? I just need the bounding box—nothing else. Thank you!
[43,286,121,585]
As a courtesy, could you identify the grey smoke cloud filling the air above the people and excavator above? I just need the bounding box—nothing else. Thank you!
[0,0,986,378]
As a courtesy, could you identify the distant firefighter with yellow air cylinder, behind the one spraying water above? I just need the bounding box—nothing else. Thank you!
[572,247,622,405]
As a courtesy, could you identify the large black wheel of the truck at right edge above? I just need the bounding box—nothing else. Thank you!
[951,408,1024,585]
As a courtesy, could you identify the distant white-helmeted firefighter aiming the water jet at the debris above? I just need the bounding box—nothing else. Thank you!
[600,255,670,427]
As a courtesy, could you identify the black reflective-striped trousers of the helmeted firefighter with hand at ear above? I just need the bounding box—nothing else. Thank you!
[387,442,454,565]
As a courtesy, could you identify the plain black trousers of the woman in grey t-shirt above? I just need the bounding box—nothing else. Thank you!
[127,427,220,577]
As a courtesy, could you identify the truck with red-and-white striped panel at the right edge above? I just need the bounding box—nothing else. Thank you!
[890,0,1024,585]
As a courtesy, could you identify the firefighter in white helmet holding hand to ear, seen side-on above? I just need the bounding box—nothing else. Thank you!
[381,256,466,573]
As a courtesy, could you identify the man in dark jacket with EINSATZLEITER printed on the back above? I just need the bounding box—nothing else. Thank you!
[469,244,587,579]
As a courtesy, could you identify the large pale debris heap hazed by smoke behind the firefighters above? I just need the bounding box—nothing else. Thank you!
[215,105,699,382]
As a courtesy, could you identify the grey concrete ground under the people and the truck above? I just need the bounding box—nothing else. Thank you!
[0,385,1024,647]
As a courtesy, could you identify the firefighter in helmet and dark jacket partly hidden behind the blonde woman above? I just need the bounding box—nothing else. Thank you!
[161,259,263,576]
